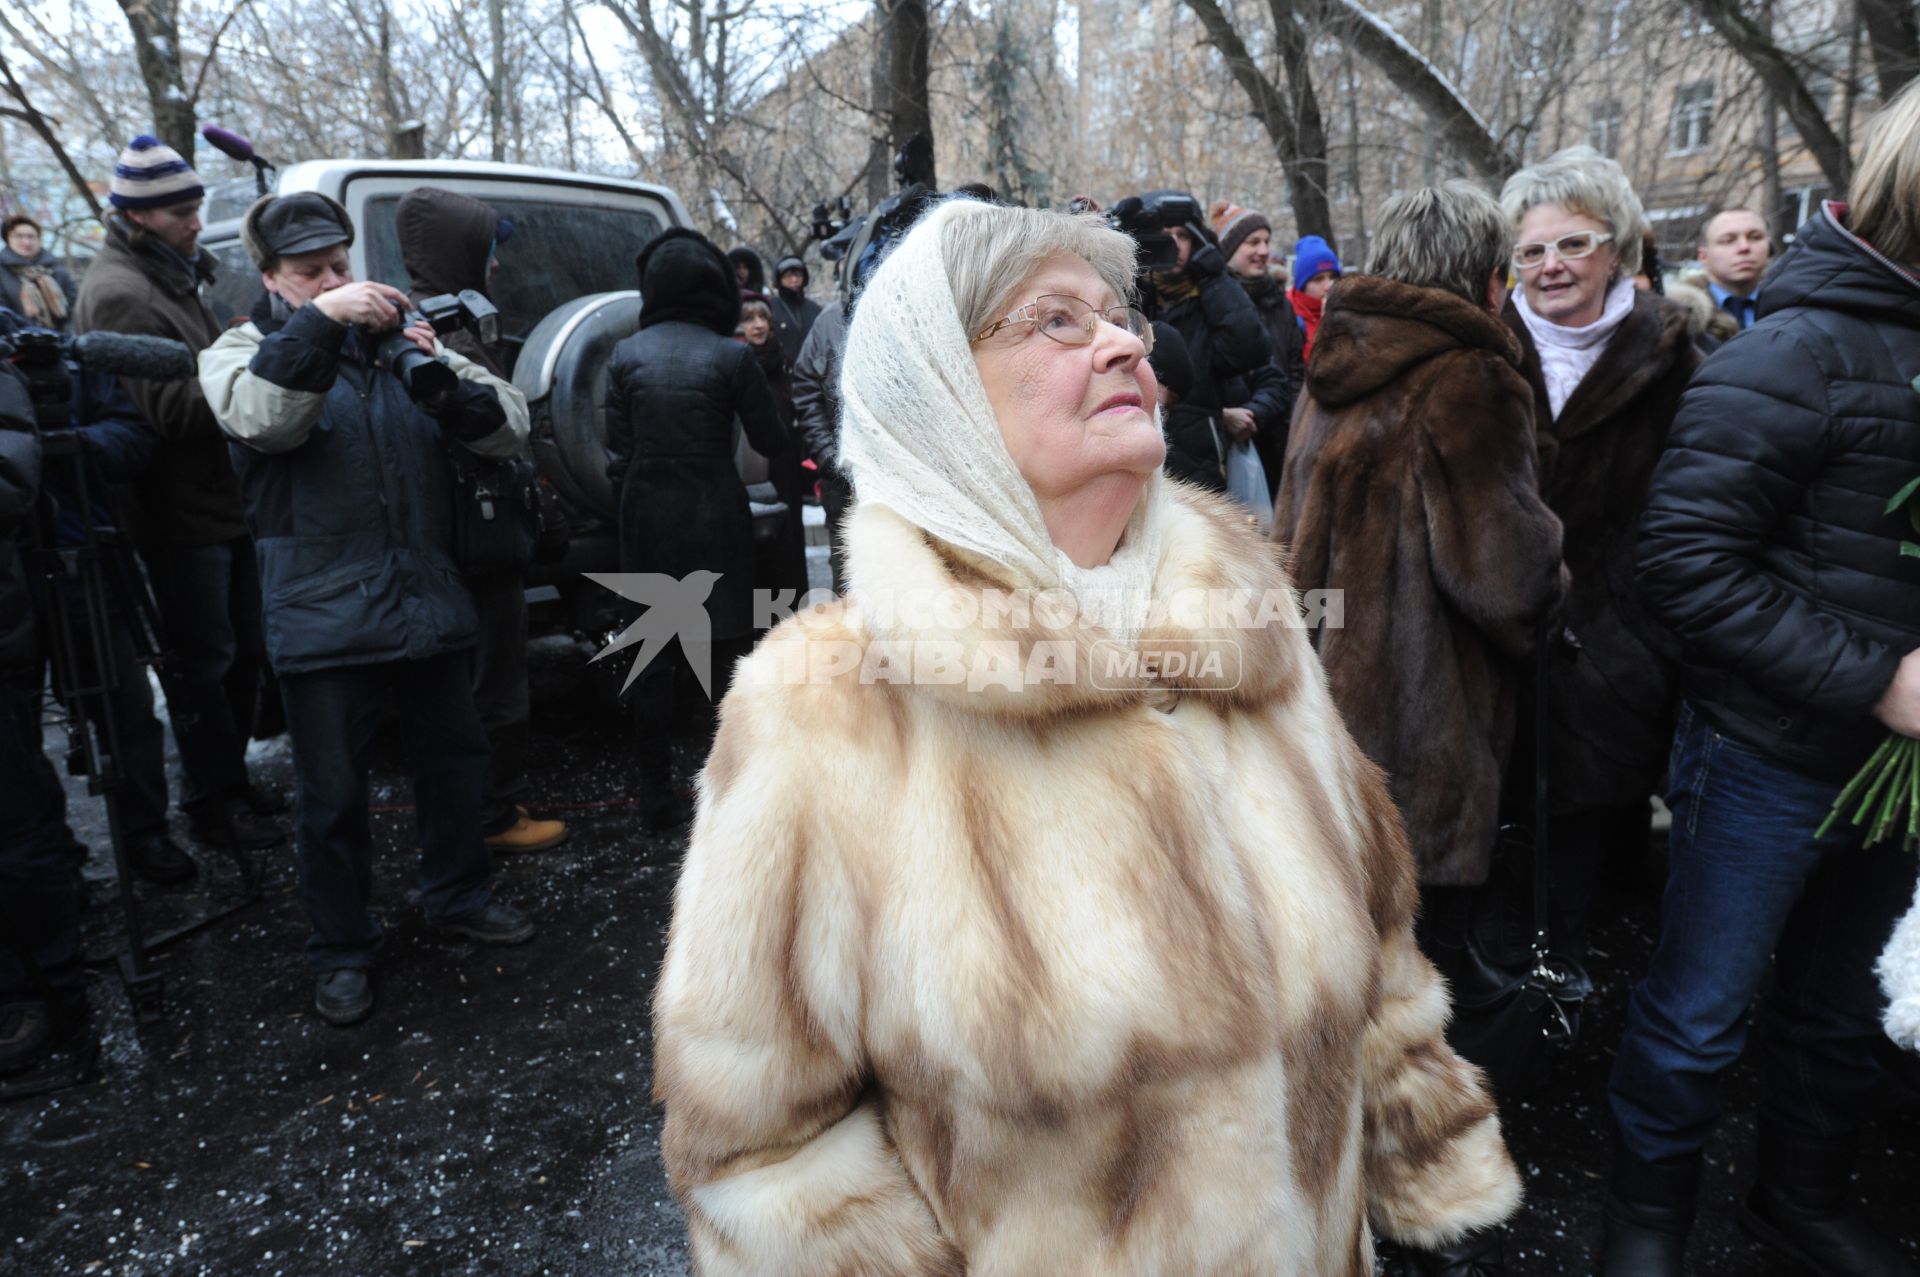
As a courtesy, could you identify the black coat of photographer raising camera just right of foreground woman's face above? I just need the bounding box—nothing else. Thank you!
[1150,275,1294,492]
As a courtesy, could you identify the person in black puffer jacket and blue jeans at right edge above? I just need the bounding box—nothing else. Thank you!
[1601,192,1920,1277]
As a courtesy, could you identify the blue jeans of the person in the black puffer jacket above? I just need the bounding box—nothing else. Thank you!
[1607,705,1914,1160]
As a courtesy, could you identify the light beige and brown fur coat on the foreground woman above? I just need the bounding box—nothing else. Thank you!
[655,486,1521,1277]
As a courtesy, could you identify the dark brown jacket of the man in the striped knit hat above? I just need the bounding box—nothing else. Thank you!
[73,213,248,545]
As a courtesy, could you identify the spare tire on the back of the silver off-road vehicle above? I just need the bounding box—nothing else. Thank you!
[513,288,639,522]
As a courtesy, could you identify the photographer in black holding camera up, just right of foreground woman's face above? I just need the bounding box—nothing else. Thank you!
[1114,190,1294,492]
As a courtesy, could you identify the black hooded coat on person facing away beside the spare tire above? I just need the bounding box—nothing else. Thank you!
[607,229,787,639]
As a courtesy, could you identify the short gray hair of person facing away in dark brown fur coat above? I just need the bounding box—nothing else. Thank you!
[1367,179,1513,305]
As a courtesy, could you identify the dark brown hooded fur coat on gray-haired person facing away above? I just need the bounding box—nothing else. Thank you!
[1273,277,1561,885]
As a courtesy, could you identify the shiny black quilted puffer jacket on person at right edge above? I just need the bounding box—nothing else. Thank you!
[1638,204,1920,780]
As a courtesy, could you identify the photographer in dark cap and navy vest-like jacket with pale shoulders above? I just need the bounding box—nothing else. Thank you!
[200,194,534,1024]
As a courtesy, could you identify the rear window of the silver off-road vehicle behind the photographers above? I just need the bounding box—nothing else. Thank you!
[361,194,660,338]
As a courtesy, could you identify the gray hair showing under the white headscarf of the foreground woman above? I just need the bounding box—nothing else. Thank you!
[941,200,1135,338]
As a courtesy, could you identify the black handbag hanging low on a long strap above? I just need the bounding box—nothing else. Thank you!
[1448,626,1594,1098]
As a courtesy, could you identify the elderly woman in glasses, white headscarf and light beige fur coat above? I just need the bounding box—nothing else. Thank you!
[655,200,1519,1277]
